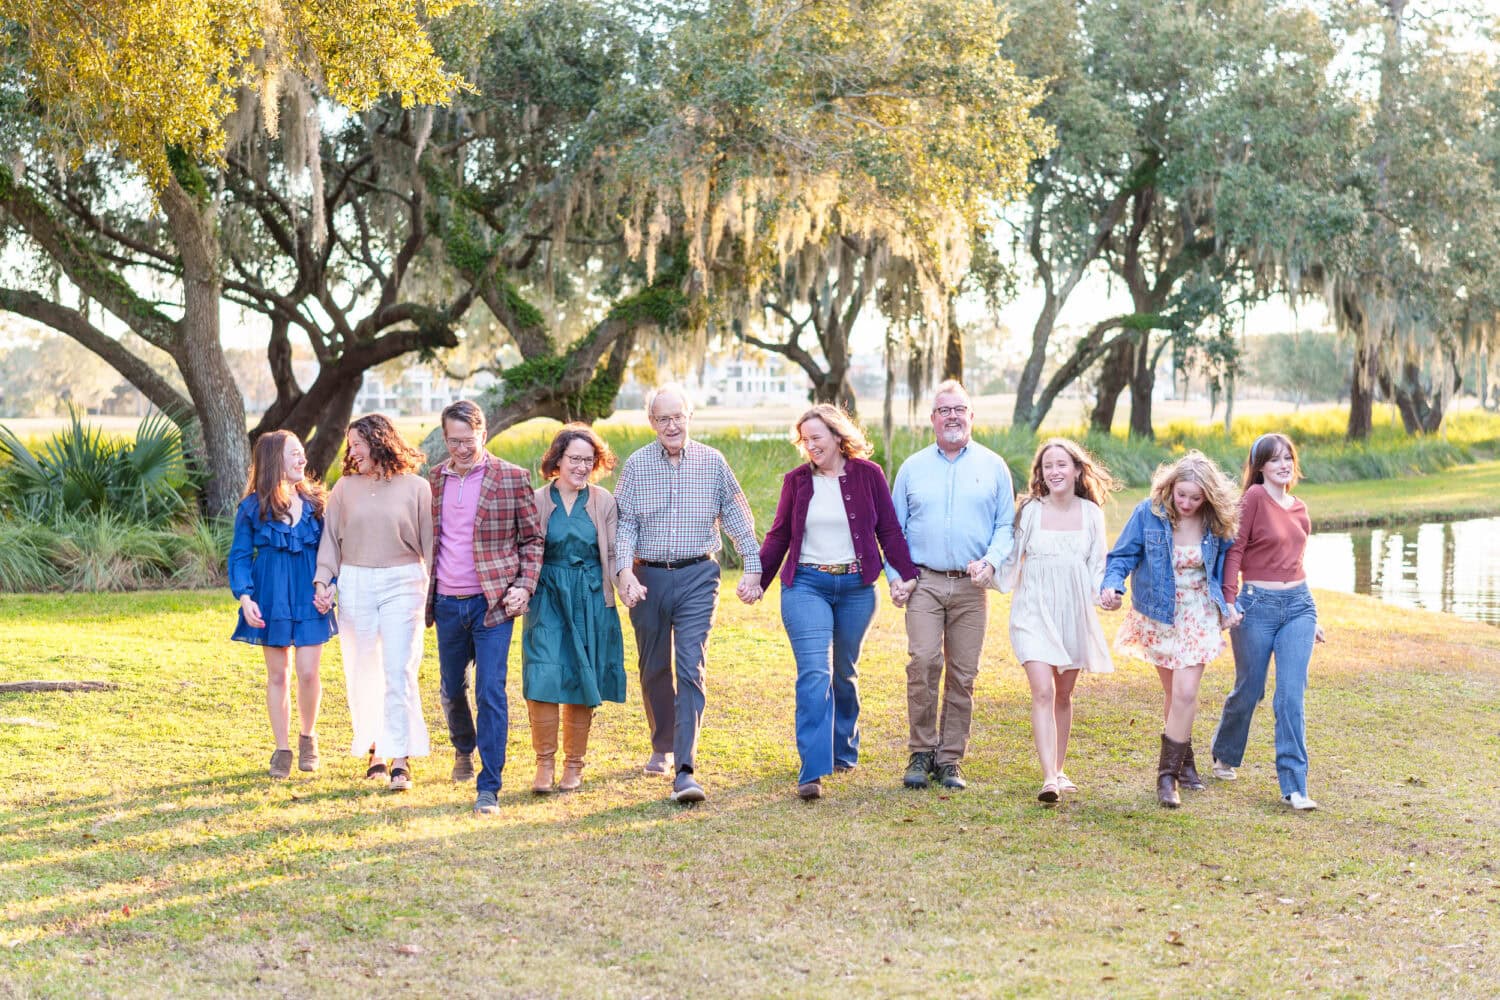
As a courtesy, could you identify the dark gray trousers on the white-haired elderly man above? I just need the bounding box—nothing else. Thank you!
[630,559,719,769]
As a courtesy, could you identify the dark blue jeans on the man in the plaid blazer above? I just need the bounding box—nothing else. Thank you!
[432,594,516,792]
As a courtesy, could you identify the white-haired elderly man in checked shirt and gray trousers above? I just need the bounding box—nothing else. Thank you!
[615,385,761,802]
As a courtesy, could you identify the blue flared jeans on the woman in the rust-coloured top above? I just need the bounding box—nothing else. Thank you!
[1214,583,1317,795]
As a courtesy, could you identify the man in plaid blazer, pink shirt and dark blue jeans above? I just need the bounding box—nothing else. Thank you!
[428,399,545,816]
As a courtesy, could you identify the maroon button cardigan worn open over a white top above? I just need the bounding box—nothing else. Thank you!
[761,459,918,586]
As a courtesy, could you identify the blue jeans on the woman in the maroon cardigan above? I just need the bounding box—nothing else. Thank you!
[782,565,875,783]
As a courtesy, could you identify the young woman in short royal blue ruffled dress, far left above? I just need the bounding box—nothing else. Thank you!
[230,430,339,778]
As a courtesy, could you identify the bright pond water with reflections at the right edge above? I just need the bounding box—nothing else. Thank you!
[1304,517,1500,625]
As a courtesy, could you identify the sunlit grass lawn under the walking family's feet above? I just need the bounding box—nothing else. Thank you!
[0,579,1500,997]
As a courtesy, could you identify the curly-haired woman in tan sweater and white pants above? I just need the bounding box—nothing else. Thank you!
[314,414,432,792]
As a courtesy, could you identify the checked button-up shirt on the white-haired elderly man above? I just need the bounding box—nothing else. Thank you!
[615,439,761,573]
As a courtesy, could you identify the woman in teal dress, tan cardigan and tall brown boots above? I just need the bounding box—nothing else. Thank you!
[521,424,626,793]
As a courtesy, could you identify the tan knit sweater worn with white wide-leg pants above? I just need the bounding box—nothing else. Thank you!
[314,475,432,583]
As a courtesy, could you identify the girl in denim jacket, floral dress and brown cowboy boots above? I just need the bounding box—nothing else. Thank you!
[1100,451,1239,808]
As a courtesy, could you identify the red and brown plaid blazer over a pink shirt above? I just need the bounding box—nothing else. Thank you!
[428,456,546,625]
